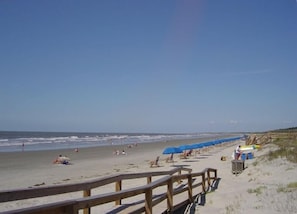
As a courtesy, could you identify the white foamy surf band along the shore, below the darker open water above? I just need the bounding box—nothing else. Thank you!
[0,131,242,154]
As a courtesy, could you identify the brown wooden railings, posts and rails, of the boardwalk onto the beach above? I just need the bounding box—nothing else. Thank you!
[0,168,217,214]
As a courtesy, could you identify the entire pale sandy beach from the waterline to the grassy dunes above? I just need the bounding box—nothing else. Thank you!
[0,139,297,214]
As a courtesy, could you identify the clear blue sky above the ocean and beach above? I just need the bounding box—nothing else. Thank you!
[0,0,297,133]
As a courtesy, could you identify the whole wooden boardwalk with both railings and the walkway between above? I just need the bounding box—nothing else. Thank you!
[0,167,217,214]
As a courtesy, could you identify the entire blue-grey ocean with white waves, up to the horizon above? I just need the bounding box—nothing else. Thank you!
[0,131,228,152]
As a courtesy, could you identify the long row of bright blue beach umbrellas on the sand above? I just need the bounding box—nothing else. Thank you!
[163,137,242,154]
